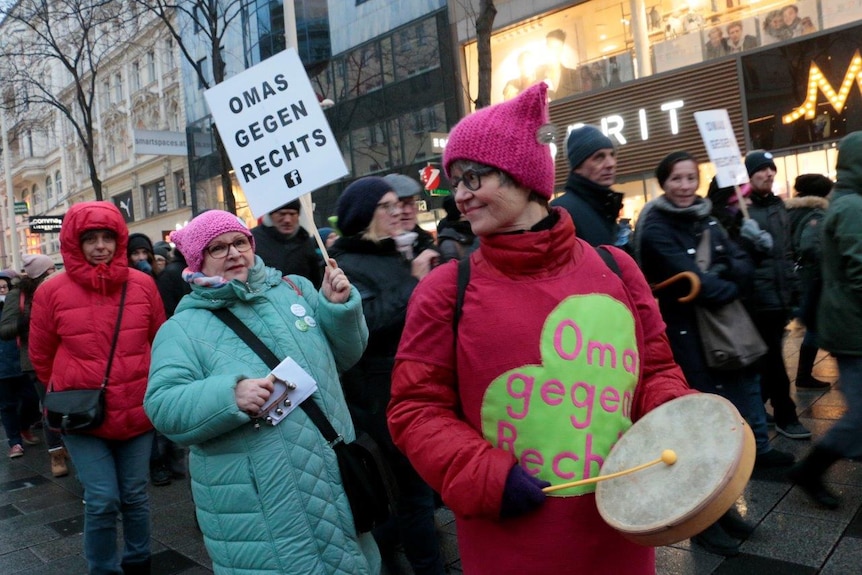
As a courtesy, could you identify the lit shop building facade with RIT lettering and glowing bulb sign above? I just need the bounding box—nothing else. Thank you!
[450,0,862,223]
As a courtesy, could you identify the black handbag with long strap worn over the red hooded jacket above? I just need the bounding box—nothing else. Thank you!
[42,284,126,433]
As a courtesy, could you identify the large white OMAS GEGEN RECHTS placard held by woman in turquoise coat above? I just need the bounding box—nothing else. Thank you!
[204,48,347,217]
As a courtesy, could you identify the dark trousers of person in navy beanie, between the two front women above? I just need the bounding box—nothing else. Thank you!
[374,453,445,575]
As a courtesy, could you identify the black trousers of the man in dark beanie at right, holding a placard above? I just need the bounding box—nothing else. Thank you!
[751,310,799,427]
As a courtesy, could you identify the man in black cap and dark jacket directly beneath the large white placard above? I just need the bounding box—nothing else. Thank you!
[251,199,323,288]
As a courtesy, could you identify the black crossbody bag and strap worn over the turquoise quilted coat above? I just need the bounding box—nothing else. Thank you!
[212,308,397,533]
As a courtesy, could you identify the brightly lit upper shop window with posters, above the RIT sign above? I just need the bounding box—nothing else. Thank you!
[466,0,862,103]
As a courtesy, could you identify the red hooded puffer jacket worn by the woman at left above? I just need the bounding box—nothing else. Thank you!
[30,202,165,440]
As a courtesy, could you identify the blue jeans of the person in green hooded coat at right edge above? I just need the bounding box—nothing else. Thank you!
[819,355,862,458]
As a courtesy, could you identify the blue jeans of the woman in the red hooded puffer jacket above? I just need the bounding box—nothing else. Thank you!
[64,431,153,575]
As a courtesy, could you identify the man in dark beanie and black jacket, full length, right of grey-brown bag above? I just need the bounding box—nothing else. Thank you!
[745,150,811,439]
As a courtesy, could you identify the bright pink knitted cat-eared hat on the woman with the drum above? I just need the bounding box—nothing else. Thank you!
[443,82,554,199]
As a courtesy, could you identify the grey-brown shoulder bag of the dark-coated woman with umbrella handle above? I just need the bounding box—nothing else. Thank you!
[694,228,767,371]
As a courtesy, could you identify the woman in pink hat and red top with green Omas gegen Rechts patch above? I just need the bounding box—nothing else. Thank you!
[388,84,692,575]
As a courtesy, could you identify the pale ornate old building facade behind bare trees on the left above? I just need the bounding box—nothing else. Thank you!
[0,2,191,267]
